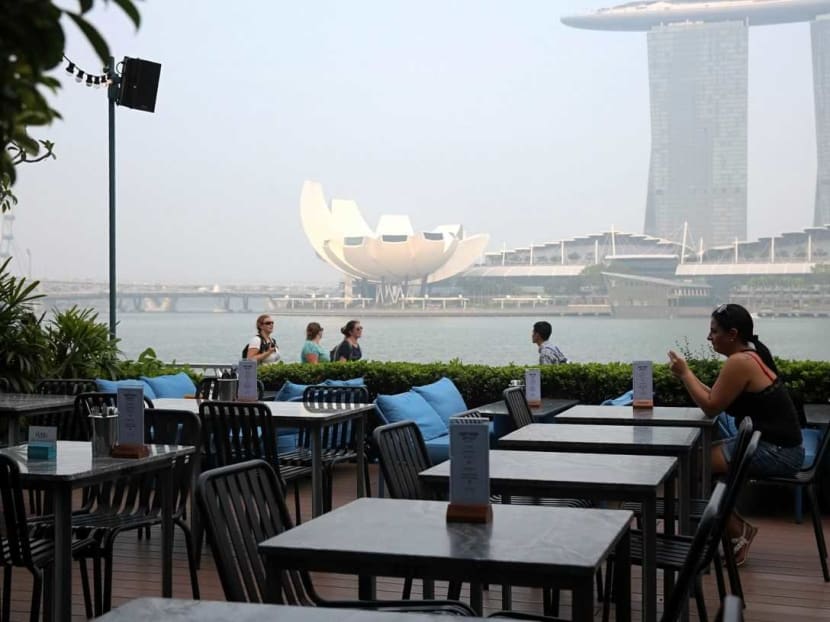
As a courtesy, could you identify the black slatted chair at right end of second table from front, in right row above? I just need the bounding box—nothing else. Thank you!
[603,432,761,622]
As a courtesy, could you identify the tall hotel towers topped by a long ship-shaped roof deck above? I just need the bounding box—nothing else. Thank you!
[562,0,830,248]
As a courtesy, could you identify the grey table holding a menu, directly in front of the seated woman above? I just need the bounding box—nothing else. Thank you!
[556,404,717,497]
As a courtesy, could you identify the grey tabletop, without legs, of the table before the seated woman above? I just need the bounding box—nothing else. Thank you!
[556,404,715,428]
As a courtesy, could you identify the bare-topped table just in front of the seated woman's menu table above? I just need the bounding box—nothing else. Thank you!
[499,423,700,534]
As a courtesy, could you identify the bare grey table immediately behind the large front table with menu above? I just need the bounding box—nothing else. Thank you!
[420,449,677,622]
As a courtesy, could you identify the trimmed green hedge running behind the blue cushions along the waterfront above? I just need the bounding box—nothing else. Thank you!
[254,360,830,408]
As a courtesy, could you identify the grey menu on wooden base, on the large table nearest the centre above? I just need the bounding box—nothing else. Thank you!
[447,412,493,523]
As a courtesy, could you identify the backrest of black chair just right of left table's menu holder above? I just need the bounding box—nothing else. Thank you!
[144,408,202,516]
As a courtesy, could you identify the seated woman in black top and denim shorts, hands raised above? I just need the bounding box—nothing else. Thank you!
[669,304,804,565]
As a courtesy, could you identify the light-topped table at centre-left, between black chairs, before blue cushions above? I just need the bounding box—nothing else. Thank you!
[153,398,375,516]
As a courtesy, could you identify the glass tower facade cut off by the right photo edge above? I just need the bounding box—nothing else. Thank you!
[810,15,830,227]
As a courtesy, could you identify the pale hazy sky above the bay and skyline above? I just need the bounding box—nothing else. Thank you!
[8,0,816,283]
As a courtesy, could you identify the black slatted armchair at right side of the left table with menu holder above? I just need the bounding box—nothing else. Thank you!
[72,408,202,615]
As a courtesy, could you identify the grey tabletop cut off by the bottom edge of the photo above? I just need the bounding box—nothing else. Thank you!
[98,598,480,622]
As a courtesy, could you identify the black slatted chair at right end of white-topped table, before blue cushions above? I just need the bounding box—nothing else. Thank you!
[280,384,372,512]
